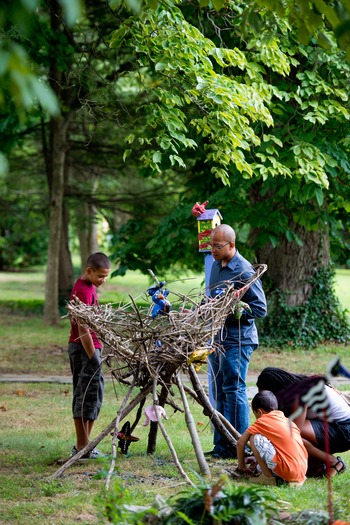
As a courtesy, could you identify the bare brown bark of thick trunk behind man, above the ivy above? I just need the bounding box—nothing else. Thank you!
[257,225,330,307]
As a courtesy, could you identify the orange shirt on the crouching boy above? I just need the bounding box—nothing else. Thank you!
[248,410,307,482]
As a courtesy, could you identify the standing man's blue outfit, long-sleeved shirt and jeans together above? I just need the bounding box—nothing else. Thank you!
[209,250,267,455]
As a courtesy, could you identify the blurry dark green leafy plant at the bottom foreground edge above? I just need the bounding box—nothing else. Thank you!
[96,478,275,525]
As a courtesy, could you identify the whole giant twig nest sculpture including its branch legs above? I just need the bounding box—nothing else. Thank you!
[52,264,267,485]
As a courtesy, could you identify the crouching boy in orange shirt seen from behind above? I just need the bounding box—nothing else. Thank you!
[237,390,308,486]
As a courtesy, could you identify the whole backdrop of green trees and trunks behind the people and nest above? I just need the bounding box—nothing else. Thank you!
[0,0,350,343]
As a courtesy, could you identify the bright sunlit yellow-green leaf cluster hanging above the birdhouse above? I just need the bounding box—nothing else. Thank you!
[116,2,273,184]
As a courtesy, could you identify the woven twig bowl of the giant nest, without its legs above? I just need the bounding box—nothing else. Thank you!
[67,265,266,386]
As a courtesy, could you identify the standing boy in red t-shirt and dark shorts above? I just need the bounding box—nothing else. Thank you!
[68,252,111,459]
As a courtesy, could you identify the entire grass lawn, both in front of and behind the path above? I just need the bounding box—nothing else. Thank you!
[0,272,350,525]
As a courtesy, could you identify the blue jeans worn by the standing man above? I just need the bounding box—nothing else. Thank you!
[208,345,257,455]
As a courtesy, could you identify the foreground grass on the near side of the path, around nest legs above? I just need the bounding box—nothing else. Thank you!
[0,376,350,525]
